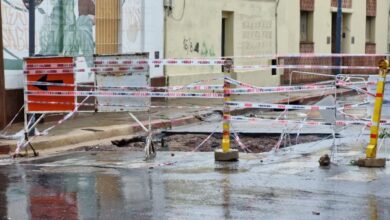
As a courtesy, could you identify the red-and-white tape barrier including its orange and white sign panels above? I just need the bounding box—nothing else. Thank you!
[12,54,390,161]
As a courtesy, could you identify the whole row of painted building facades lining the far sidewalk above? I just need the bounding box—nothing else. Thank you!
[0,0,390,127]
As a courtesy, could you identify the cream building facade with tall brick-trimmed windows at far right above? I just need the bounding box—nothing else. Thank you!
[278,0,389,54]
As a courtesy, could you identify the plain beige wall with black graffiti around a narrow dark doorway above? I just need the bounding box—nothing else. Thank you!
[165,0,280,85]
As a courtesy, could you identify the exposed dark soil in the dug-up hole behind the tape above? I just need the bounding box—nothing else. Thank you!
[71,134,323,153]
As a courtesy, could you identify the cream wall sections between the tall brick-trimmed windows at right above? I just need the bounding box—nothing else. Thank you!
[277,0,389,54]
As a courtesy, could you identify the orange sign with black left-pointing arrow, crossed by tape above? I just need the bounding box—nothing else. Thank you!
[24,57,76,113]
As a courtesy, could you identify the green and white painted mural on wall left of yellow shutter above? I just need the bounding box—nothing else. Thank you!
[1,0,95,88]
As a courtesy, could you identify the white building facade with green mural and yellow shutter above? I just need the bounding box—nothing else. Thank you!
[0,0,164,128]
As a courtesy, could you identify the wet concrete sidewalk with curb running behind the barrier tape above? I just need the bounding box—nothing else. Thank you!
[0,88,348,156]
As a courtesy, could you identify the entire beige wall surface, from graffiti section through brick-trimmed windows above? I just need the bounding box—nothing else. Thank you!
[165,0,389,86]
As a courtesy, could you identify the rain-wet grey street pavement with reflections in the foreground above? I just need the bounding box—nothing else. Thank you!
[0,133,390,219]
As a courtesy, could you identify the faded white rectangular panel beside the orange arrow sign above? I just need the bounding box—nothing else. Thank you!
[94,53,151,112]
